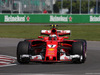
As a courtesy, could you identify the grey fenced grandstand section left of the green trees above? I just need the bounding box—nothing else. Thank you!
[0,0,53,13]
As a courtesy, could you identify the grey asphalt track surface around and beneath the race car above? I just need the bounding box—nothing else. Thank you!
[0,38,100,75]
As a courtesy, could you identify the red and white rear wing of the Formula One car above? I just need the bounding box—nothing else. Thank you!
[41,30,71,36]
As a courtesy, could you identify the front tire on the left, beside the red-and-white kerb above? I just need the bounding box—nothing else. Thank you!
[17,41,30,64]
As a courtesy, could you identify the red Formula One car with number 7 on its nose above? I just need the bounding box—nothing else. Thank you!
[17,25,87,64]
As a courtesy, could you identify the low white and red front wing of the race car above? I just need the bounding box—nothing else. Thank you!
[21,54,82,62]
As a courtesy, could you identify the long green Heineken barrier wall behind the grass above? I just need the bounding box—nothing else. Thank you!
[0,14,100,23]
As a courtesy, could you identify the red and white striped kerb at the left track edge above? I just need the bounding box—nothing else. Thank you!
[0,55,16,67]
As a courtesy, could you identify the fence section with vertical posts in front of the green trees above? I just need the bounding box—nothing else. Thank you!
[59,0,100,14]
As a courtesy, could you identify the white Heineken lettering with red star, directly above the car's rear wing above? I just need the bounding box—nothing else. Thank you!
[50,16,72,22]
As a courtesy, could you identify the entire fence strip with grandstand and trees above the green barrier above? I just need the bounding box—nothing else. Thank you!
[0,0,100,14]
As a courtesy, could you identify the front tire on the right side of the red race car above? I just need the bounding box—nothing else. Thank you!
[72,42,86,63]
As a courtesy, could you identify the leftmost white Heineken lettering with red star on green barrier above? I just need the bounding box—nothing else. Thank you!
[4,15,30,22]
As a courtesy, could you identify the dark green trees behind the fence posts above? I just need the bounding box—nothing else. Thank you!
[56,0,96,14]
